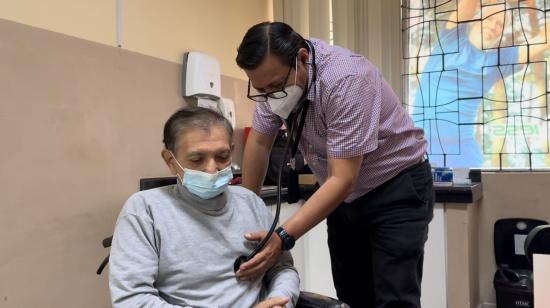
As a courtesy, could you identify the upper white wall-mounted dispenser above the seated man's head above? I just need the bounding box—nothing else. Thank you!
[182,51,221,99]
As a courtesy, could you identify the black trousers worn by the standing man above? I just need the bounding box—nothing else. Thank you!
[327,161,434,308]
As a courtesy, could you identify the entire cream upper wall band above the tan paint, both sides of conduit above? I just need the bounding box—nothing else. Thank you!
[0,0,272,79]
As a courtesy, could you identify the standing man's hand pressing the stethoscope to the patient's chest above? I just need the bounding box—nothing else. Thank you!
[236,231,282,280]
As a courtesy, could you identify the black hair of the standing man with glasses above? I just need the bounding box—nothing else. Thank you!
[236,22,309,70]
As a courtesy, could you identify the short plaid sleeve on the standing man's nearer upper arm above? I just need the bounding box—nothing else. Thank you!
[325,75,382,158]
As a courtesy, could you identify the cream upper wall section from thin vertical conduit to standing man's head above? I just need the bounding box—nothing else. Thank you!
[122,0,271,79]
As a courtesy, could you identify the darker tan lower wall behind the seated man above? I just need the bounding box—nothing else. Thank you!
[0,19,254,308]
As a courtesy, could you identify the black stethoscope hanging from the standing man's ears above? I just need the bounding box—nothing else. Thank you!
[233,40,317,272]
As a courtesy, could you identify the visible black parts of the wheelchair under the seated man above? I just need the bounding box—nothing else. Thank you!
[96,177,349,308]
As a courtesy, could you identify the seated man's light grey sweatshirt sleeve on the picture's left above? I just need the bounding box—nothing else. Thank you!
[109,198,188,308]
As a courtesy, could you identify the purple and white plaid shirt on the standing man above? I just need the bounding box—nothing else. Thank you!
[252,39,427,202]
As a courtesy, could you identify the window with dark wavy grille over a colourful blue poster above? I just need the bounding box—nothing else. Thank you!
[402,0,550,169]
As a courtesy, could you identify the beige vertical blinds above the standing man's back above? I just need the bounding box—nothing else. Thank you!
[273,0,403,97]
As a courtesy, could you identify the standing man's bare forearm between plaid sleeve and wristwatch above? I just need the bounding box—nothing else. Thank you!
[283,177,354,239]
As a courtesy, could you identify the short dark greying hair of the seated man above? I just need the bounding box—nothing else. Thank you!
[162,107,233,155]
